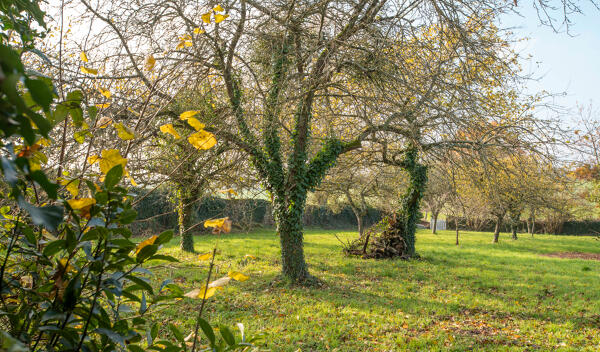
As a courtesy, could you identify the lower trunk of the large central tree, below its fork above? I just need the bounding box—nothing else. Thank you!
[273,197,310,283]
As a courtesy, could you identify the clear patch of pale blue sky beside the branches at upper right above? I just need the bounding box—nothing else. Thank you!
[501,0,600,114]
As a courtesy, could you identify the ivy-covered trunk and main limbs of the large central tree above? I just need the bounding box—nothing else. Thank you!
[222,36,360,283]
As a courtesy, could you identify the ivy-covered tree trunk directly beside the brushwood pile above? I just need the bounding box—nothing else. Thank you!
[396,146,427,257]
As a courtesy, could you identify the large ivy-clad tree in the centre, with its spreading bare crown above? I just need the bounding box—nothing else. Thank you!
[65,0,596,282]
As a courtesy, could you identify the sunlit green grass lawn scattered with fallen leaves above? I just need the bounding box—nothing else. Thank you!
[148,230,600,351]
